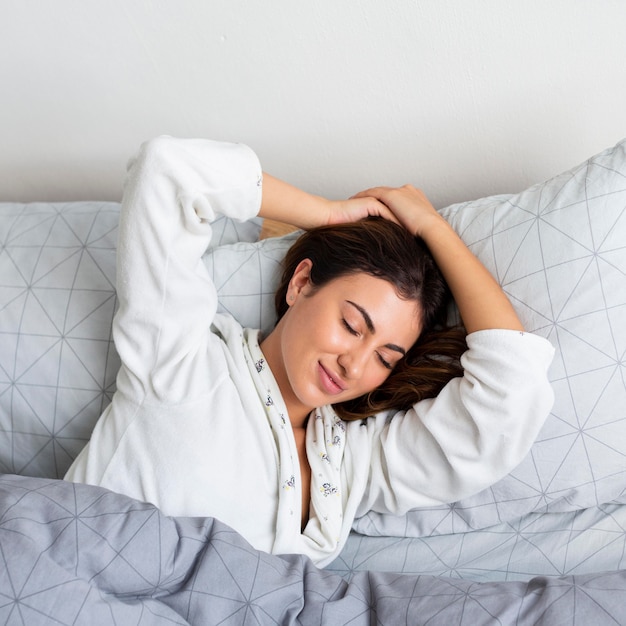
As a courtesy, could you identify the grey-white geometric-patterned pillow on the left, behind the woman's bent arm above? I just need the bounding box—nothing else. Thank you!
[0,202,262,478]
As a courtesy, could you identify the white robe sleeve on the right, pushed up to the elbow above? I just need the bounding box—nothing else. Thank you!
[351,330,554,516]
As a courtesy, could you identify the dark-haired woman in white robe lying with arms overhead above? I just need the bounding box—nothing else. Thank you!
[66,138,553,565]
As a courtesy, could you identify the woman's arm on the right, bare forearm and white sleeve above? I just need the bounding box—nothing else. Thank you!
[352,186,554,513]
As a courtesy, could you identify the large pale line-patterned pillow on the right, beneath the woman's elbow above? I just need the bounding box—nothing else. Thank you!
[355,136,626,536]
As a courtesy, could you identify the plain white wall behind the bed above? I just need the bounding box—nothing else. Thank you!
[0,0,626,206]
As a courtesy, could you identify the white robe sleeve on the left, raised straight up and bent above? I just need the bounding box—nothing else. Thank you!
[113,137,262,401]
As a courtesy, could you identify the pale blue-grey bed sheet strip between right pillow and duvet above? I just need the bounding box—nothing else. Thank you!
[327,503,626,582]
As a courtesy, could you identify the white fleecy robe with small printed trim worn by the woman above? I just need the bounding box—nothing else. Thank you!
[65,137,553,566]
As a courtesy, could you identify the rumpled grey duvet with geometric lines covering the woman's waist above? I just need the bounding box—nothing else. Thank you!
[0,475,626,626]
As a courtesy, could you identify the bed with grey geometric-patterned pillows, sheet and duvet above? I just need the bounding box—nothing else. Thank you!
[0,140,626,626]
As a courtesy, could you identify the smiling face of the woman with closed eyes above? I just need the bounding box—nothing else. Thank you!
[261,260,420,419]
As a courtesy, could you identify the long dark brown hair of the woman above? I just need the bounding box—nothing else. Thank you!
[275,218,467,420]
